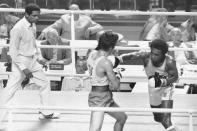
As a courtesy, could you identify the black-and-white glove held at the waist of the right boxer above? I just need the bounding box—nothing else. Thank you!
[148,72,167,88]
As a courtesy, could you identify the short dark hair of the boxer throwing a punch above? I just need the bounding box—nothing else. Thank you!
[149,39,168,54]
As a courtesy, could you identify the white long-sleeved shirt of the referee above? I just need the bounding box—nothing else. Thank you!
[10,17,38,68]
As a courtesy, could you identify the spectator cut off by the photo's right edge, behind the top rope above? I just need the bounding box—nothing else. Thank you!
[180,5,197,42]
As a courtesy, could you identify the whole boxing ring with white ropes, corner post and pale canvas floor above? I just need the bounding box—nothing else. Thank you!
[0,8,197,131]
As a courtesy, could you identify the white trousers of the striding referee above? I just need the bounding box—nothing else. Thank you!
[0,56,50,125]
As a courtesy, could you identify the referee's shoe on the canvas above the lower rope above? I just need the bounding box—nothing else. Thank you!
[38,111,60,120]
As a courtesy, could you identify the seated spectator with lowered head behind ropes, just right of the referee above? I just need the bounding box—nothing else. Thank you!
[41,29,72,90]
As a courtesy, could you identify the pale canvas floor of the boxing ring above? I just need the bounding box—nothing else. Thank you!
[0,91,197,131]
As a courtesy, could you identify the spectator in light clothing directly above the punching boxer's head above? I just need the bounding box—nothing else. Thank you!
[139,8,173,41]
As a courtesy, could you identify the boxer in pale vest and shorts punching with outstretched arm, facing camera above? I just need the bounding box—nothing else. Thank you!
[119,39,182,131]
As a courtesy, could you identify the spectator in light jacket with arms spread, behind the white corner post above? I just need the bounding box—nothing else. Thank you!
[38,4,103,40]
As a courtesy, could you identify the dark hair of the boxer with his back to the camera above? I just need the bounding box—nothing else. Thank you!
[96,31,118,51]
